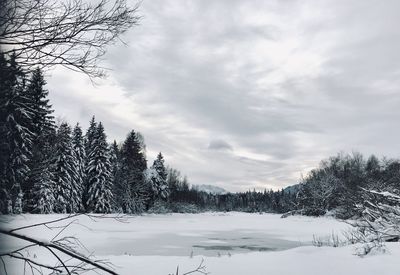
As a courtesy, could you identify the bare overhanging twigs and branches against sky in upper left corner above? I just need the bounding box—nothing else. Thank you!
[0,0,140,77]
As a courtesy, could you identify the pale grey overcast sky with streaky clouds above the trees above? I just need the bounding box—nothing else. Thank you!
[48,0,400,191]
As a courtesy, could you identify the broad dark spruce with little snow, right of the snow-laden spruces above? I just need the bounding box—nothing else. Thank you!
[115,130,150,213]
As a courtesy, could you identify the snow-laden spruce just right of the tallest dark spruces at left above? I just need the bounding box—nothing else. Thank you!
[54,123,80,213]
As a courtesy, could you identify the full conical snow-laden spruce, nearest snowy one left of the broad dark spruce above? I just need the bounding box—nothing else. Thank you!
[86,123,112,213]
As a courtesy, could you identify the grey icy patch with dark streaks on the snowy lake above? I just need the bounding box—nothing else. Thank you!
[90,230,306,256]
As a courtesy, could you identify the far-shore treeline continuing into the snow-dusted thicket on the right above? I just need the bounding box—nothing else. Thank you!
[174,153,400,219]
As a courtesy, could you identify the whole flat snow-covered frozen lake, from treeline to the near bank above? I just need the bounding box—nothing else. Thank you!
[0,213,346,257]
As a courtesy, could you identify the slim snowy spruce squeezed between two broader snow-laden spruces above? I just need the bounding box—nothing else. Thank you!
[72,123,86,211]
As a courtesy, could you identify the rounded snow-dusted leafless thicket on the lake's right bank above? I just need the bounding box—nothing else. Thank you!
[294,153,400,218]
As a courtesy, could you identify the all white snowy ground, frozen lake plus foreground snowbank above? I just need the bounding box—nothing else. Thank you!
[1,213,400,275]
